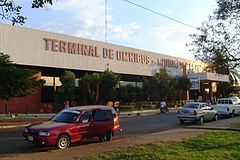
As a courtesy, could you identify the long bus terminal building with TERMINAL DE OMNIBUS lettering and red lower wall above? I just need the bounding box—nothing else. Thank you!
[0,24,229,114]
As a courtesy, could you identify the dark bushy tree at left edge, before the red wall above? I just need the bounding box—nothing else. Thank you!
[0,53,44,100]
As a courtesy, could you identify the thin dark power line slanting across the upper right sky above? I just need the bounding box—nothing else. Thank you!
[123,0,197,29]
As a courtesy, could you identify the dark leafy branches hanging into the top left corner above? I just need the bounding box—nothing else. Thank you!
[0,0,52,25]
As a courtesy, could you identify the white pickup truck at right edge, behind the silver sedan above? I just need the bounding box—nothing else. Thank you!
[214,97,240,117]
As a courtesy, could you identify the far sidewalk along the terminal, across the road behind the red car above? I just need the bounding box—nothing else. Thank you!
[0,108,176,129]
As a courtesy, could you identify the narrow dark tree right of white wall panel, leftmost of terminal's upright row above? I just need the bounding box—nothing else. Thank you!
[56,71,75,106]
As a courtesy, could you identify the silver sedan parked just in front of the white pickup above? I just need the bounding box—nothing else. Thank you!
[177,102,218,124]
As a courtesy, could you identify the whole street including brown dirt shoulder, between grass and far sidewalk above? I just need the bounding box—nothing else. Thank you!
[0,113,240,160]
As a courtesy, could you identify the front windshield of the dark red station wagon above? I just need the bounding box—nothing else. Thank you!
[51,110,80,123]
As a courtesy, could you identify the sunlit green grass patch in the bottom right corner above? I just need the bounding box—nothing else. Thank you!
[84,131,240,160]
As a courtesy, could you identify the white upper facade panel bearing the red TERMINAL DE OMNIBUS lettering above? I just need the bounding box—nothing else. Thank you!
[0,24,204,76]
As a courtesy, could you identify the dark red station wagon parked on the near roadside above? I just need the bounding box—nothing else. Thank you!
[23,106,121,149]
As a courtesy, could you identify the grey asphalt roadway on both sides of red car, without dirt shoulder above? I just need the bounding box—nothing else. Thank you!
[0,113,181,154]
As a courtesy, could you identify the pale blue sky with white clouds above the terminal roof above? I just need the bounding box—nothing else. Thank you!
[4,0,217,59]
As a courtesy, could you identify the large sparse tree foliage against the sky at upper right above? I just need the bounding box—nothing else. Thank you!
[188,0,240,79]
